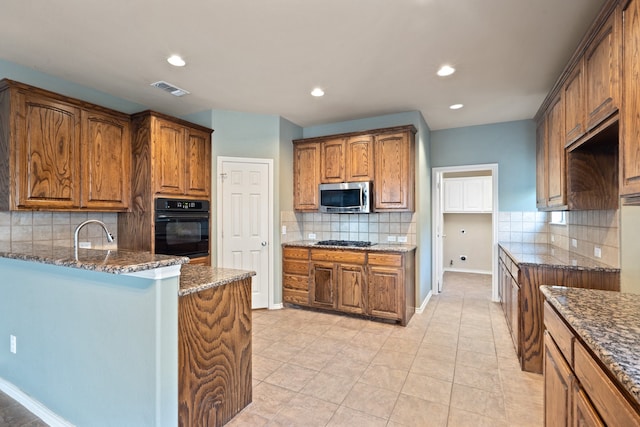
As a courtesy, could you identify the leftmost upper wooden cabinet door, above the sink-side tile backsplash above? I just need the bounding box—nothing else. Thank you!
[15,94,80,209]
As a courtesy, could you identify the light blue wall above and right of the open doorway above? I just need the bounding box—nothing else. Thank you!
[431,120,536,211]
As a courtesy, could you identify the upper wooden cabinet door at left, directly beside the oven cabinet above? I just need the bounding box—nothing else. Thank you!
[81,110,131,210]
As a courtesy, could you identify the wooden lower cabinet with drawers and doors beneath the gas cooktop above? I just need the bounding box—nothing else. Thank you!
[282,246,415,326]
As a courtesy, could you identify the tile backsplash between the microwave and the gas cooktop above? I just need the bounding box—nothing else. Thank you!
[280,211,416,245]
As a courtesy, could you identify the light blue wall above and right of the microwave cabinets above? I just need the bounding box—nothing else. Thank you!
[303,111,432,306]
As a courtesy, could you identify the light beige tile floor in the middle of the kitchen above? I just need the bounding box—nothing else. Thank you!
[229,273,543,427]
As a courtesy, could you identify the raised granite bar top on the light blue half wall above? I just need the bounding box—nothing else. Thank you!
[0,242,189,274]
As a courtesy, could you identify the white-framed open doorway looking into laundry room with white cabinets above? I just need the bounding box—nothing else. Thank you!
[431,163,499,301]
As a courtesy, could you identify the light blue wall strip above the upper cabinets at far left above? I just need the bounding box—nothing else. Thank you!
[0,59,147,114]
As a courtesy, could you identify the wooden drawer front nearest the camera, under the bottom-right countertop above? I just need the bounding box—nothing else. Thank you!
[574,342,640,426]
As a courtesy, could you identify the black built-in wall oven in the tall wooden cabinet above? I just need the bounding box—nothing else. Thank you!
[155,198,210,258]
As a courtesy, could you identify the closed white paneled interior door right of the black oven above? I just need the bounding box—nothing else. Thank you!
[218,157,273,308]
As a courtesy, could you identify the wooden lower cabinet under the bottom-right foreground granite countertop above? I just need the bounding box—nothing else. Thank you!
[544,302,640,427]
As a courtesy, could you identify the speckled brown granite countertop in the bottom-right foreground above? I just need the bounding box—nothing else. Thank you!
[540,286,640,405]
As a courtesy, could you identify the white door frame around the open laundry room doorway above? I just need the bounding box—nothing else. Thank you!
[431,163,499,301]
